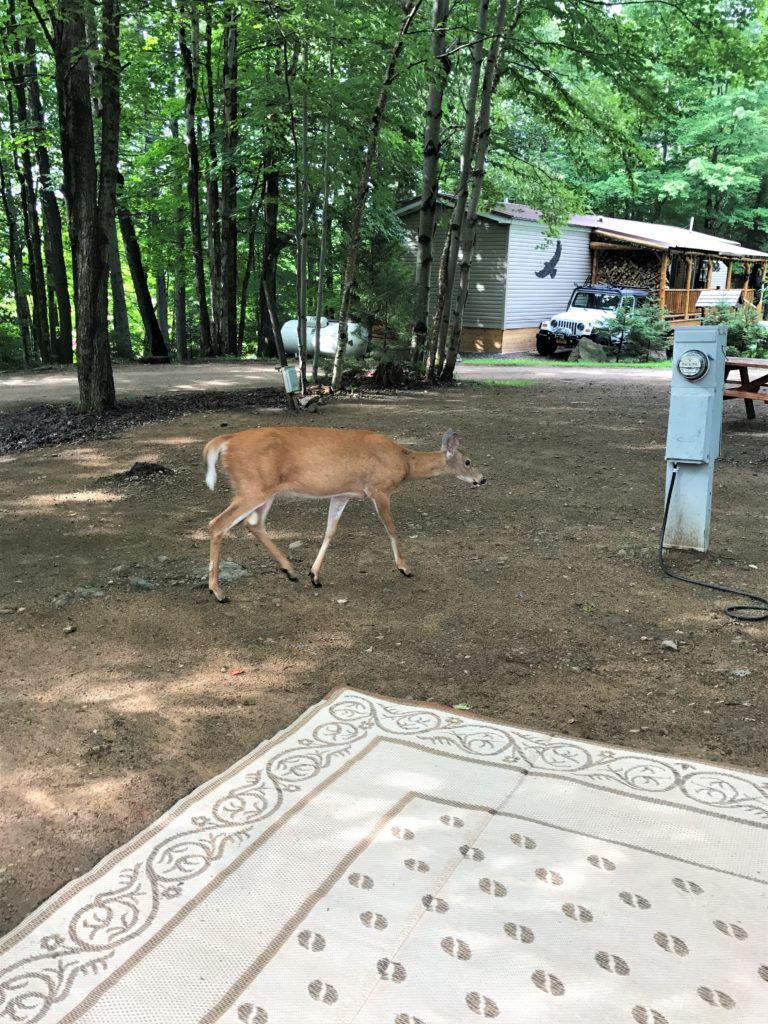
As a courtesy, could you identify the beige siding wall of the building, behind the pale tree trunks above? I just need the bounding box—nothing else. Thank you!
[402,213,509,329]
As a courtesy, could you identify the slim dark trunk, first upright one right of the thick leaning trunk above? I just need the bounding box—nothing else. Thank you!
[178,23,213,358]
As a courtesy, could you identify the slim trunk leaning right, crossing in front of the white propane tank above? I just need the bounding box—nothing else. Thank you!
[331,0,422,389]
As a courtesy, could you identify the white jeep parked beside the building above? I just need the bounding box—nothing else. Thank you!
[536,285,648,355]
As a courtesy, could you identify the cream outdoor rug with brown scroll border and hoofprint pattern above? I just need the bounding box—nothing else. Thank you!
[0,689,768,1024]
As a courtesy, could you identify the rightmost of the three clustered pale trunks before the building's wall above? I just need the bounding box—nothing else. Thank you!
[440,0,520,381]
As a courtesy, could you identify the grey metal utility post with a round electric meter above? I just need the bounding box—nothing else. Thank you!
[664,324,727,551]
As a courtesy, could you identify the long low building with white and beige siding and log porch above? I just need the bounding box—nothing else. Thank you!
[397,196,768,352]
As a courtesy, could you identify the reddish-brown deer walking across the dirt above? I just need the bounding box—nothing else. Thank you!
[203,427,485,602]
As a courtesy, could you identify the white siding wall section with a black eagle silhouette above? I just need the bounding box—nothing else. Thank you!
[504,220,592,328]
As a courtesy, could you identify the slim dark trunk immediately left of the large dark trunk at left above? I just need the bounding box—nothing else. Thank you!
[26,37,73,362]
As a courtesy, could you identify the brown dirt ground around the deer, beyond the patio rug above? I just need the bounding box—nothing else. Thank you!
[0,371,768,933]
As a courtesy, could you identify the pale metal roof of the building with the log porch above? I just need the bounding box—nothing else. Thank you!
[495,203,768,259]
